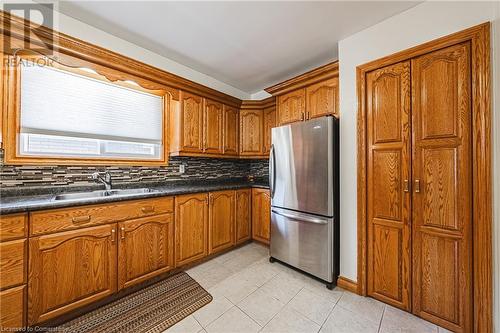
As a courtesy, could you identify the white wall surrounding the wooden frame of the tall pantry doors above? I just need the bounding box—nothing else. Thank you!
[339,2,500,331]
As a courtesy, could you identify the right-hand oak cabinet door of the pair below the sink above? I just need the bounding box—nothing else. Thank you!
[118,214,174,289]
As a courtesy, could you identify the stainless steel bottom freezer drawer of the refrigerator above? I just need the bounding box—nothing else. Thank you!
[270,207,334,282]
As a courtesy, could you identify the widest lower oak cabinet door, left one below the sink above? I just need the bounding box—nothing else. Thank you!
[28,224,117,325]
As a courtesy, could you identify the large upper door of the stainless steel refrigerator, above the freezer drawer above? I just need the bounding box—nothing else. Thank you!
[269,117,334,216]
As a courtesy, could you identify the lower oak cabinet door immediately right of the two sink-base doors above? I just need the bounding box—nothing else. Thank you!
[175,193,208,266]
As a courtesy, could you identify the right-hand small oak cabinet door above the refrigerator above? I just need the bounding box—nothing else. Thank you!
[306,77,339,119]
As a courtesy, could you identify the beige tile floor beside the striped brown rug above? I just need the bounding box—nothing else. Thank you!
[166,243,447,333]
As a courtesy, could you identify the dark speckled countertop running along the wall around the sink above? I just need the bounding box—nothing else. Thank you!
[0,180,269,215]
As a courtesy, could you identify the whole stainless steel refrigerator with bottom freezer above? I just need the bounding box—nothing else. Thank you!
[269,117,339,288]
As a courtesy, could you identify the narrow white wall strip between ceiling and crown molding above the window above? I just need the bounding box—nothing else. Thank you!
[48,5,251,99]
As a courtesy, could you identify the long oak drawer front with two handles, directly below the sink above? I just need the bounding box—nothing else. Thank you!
[30,197,174,235]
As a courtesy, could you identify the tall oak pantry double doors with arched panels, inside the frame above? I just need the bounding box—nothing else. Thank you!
[366,42,473,332]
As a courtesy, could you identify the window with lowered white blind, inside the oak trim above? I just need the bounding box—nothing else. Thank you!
[20,62,163,159]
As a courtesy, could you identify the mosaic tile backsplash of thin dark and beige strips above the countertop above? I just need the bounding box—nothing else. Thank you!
[0,151,269,189]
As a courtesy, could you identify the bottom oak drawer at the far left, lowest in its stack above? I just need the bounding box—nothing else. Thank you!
[0,286,26,331]
